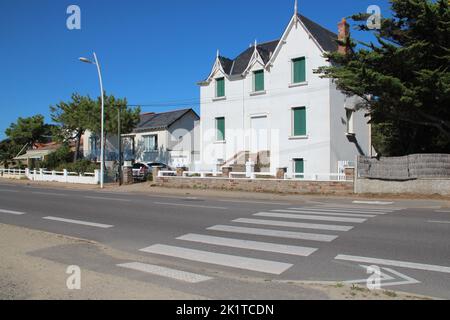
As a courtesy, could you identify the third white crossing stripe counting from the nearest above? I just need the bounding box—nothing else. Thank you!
[177,234,318,257]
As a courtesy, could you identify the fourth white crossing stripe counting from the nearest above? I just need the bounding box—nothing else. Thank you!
[207,225,338,242]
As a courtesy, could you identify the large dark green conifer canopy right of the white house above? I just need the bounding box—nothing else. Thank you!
[318,0,450,155]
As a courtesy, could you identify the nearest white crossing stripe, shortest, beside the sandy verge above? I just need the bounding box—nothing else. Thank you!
[117,262,213,283]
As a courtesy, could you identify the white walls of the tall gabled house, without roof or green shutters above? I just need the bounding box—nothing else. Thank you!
[200,14,371,174]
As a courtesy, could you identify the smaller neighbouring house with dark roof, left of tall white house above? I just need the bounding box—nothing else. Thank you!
[84,109,200,169]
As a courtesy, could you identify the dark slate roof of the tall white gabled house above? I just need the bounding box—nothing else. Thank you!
[215,14,338,75]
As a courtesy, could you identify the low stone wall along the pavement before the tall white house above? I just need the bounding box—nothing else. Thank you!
[155,177,354,195]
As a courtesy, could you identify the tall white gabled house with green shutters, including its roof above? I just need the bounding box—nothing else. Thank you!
[199,3,371,175]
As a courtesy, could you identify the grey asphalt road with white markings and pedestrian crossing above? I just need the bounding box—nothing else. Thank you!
[0,182,450,299]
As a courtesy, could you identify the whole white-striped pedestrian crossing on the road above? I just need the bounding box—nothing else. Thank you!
[118,204,401,282]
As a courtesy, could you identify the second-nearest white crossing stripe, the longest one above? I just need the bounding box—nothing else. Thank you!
[140,244,293,275]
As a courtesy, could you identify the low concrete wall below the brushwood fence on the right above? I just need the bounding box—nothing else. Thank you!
[355,178,450,195]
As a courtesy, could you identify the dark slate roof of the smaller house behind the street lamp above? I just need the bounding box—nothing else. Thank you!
[133,109,199,133]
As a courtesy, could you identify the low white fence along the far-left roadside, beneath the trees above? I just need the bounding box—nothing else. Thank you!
[0,169,100,184]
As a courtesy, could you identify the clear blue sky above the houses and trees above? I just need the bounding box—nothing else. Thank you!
[0,0,389,139]
